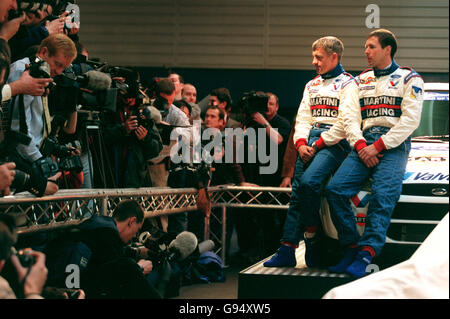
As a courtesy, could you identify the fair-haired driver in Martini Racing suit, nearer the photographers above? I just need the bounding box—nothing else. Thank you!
[264,36,352,267]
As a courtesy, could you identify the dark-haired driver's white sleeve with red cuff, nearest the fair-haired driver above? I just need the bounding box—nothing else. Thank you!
[339,79,367,151]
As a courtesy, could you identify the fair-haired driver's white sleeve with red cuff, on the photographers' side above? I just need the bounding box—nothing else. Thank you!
[293,83,314,149]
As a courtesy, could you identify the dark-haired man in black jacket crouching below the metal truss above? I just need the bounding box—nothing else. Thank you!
[46,200,160,299]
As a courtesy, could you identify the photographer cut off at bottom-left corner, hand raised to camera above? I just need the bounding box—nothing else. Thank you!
[0,215,47,299]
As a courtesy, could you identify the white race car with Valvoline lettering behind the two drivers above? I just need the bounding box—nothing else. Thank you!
[321,83,449,266]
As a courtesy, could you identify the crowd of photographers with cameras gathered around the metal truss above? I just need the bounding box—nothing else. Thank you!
[0,0,295,298]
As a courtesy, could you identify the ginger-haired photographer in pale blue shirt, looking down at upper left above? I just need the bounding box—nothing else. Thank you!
[8,34,76,195]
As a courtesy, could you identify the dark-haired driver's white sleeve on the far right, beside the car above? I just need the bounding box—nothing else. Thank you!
[374,74,423,152]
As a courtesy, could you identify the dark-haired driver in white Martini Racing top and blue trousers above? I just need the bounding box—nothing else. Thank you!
[326,29,423,277]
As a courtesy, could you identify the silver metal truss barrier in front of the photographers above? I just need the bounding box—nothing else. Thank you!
[0,186,291,264]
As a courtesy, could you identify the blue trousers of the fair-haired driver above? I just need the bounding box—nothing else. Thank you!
[281,128,350,245]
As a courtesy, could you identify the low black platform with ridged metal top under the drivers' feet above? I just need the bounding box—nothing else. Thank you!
[238,241,354,299]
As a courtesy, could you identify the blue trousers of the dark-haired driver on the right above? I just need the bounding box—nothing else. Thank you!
[326,126,411,255]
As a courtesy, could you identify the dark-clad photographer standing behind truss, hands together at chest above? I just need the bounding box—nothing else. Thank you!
[100,68,162,188]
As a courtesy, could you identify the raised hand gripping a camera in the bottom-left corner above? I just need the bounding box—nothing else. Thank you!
[11,251,48,296]
